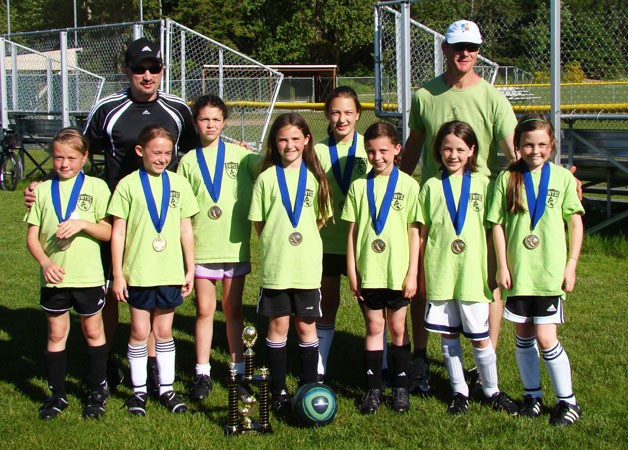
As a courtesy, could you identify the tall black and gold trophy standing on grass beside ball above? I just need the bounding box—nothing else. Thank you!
[225,325,273,436]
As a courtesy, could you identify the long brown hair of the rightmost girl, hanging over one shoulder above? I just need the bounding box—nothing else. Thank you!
[506,113,556,214]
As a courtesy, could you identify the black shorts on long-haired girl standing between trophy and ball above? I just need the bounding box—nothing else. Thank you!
[257,288,323,318]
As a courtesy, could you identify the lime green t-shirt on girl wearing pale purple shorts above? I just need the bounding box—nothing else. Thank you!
[177,143,261,264]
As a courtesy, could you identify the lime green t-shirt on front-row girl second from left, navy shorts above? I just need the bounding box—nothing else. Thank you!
[108,170,198,287]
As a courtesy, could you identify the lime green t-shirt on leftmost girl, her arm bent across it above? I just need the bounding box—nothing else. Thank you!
[27,176,110,288]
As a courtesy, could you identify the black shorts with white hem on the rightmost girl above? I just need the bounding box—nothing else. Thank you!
[504,295,565,324]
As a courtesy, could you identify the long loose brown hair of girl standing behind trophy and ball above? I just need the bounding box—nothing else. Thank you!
[261,113,332,222]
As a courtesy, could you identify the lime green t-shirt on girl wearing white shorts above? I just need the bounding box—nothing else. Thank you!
[419,172,492,302]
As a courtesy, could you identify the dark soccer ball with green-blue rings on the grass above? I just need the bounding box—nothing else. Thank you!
[292,383,338,427]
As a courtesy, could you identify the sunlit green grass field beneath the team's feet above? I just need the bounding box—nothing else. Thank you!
[0,184,628,449]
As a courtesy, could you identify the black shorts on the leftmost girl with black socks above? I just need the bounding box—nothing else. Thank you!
[39,286,105,316]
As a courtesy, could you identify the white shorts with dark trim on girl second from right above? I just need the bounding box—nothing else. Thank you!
[425,300,488,341]
